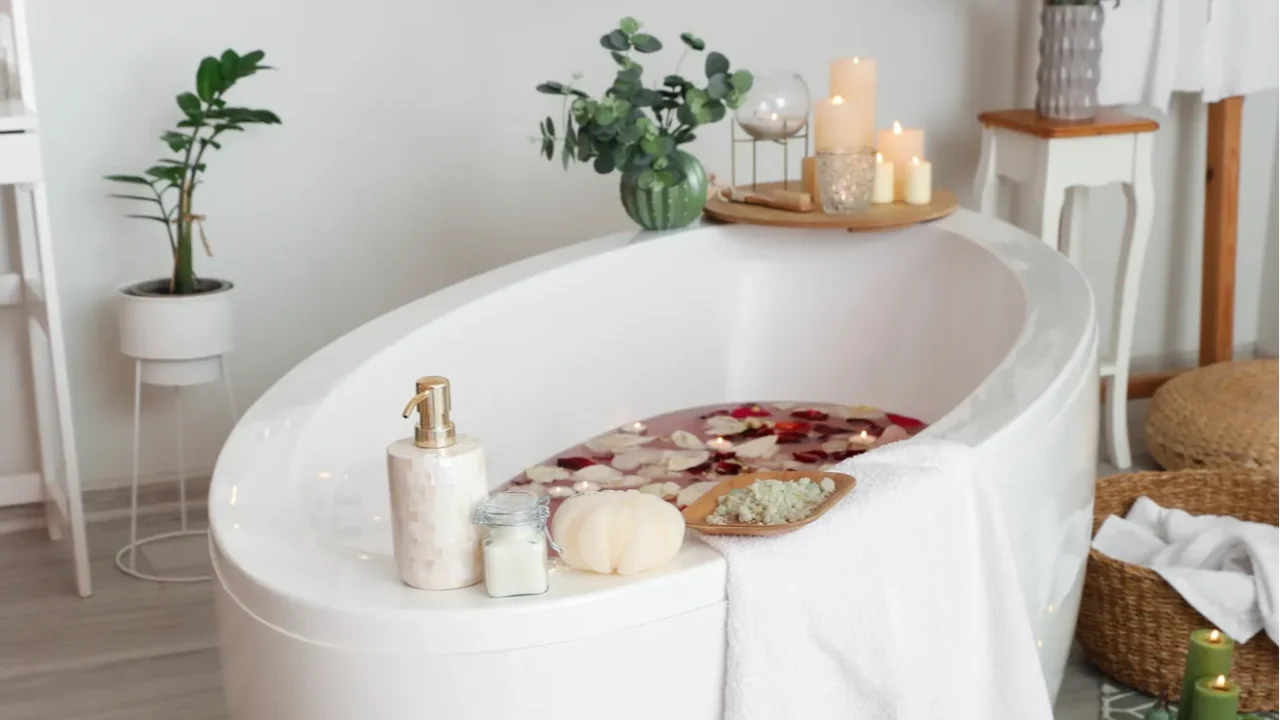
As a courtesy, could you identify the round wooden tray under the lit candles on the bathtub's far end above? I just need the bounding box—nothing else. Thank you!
[703,181,960,232]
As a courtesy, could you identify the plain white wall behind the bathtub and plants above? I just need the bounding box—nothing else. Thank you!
[0,0,1276,484]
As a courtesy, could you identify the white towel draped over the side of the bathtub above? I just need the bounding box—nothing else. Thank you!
[704,441,1052,720]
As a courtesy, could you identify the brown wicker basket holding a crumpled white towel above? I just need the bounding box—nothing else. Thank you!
[1076,470,1280,711]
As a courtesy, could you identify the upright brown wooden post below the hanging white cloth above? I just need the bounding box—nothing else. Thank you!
[1199,95,1244,365]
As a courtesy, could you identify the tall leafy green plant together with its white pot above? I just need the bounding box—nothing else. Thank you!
[106,50,280,384]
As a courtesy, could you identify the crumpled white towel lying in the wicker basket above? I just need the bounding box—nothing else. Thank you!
[1093,496,1280,643]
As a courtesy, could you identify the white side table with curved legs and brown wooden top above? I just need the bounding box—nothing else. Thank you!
[974,109,1160,469]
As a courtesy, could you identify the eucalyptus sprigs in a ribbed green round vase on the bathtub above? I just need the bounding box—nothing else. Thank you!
[535,18,753,229]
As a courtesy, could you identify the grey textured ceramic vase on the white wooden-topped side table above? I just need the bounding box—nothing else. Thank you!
[1036,5,1103,120]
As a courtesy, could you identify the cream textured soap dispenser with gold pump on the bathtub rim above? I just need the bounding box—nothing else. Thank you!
[387,375,489,591]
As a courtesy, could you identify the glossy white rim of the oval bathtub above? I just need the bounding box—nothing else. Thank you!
[209,210,1093,653]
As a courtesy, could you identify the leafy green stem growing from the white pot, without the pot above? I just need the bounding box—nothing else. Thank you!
[106,50,280,295]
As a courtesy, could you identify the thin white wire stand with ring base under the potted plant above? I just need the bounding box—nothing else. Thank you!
[115,355,238,583]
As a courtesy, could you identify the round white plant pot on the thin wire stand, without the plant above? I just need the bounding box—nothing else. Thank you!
[119,278,234,386]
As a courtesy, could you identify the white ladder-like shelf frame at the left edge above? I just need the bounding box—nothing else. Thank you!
[0,0,93,597]
